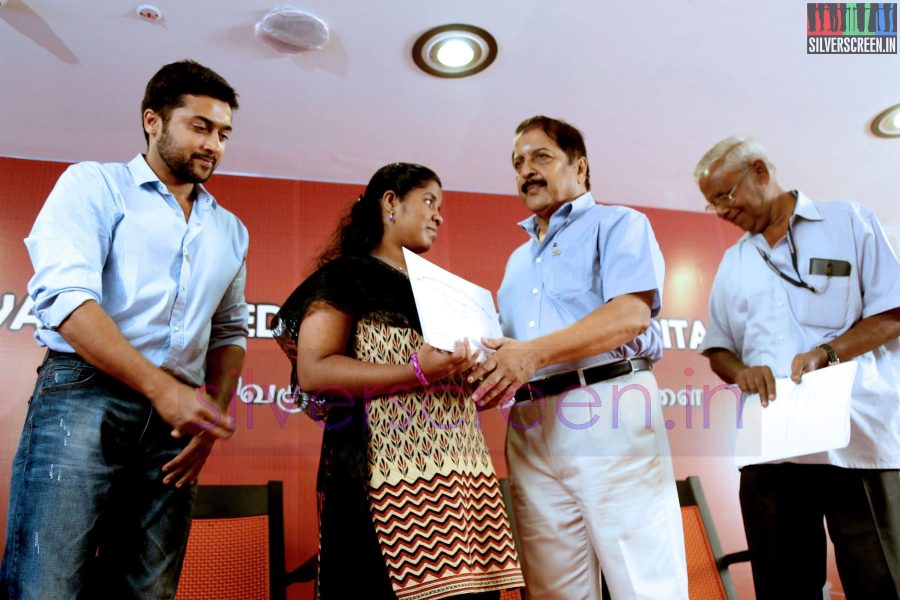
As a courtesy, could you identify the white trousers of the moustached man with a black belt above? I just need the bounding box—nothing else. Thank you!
[506,371,688,600]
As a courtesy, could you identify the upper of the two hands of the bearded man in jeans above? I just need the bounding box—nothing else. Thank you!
[150,379,234,438]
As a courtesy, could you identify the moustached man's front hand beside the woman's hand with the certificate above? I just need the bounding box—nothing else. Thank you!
[468,338,539,408]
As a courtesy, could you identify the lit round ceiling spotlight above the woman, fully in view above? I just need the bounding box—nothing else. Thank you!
[413,24,497,77]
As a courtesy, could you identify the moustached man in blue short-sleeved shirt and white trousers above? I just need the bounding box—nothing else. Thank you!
[471,116,688,600]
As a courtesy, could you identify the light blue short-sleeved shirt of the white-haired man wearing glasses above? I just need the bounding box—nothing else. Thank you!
[701,194,900,469]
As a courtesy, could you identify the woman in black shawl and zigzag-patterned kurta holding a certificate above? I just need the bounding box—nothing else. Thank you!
[274,163,523,600]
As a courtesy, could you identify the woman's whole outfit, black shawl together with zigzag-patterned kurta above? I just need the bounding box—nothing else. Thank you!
[272,257,524,600]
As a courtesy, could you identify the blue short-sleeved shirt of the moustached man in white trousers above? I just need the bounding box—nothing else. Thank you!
[497,193,665,377]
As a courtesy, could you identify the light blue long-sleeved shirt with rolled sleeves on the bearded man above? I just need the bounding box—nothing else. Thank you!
[25,154,249,385]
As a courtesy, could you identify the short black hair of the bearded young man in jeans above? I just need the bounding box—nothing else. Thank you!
[141,60,238,143]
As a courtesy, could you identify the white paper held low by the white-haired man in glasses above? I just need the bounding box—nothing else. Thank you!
[734,361,857,467]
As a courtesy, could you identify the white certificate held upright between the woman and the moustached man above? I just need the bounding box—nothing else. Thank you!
[403,248,503,361]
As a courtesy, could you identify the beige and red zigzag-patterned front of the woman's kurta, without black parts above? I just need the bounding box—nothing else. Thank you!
[355,321,523,600]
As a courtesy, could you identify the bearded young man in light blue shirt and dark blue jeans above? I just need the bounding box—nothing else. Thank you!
[0,61,248,600]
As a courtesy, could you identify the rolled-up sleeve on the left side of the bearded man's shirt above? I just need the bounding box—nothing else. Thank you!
[25,163,117,330]
